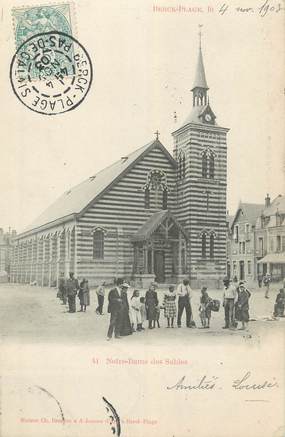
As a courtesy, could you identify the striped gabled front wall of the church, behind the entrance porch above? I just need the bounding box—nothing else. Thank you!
[77,147,176,282]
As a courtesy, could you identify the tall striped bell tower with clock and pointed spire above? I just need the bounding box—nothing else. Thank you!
[172,26,229,288]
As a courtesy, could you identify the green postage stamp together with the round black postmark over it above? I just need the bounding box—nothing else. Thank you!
[10,3,93,115]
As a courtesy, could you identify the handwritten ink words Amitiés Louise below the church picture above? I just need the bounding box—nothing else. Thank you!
[166,371,279,391]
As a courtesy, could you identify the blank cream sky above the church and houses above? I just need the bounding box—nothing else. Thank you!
[0,0,285,231]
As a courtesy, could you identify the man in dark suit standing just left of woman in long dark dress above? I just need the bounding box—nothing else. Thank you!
[107,278,124,340]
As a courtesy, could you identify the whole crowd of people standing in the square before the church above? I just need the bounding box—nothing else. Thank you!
[57,273,285,340]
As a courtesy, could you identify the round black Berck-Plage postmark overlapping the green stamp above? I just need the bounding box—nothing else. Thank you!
[10,31,93,115]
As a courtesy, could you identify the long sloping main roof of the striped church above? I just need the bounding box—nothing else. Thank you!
[23,140,175,233]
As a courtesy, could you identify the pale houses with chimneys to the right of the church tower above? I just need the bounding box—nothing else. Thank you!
[227,194,285,283]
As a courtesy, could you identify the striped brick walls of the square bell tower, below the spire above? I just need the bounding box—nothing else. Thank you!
[173,123,227,286]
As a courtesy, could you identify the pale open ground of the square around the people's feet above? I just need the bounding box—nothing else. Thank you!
[0,284,285,345]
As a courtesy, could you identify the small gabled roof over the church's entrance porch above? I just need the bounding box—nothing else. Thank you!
[132,210,187,241]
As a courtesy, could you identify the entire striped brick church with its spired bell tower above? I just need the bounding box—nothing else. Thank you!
[11,35,228,288]
